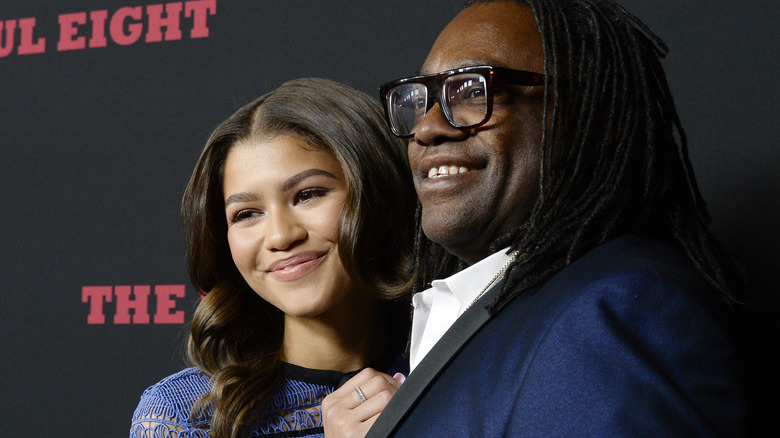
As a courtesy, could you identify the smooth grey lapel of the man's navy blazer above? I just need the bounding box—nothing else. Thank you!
[366,280,504,438]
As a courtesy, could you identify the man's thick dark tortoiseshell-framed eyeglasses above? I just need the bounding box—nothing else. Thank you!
[379,65,545,138]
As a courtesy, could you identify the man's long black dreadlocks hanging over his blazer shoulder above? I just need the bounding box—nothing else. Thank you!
[414,0,741,311]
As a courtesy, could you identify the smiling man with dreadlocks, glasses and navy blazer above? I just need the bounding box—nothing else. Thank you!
[325,0,746,437]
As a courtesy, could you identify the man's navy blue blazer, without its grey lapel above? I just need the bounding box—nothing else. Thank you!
[368,236,745,437]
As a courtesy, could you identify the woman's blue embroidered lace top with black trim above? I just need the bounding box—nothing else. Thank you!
[130,361,408,438]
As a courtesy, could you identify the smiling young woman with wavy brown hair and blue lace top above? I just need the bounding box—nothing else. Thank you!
[130,79,416,438]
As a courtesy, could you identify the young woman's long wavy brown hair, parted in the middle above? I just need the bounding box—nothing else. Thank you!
[181,79,416,437]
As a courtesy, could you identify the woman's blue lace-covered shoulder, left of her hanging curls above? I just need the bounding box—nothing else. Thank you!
[131,368,211,436]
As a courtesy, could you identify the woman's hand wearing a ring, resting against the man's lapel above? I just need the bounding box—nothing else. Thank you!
[322,368,405,438]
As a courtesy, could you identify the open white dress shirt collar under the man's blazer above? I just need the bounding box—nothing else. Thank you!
[409,248,509,372]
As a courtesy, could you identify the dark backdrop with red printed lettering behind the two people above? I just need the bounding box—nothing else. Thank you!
[0,0,780,437]
